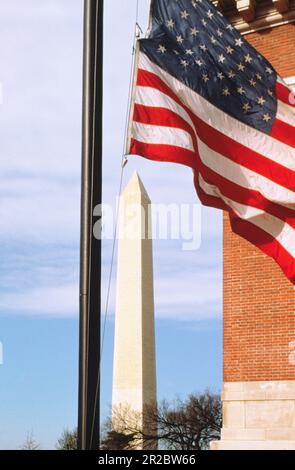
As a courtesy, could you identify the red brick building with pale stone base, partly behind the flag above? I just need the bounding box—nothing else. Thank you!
[212,0,295,449]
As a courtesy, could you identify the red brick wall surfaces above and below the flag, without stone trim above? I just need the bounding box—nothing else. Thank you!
[223,24,295,382]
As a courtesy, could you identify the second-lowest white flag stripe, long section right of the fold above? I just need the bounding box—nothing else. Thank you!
[198,138,295,209]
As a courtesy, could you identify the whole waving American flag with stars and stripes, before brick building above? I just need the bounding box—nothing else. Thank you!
[126,0,295,284]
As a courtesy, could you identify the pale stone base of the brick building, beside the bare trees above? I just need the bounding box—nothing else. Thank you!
[211,380,295,450]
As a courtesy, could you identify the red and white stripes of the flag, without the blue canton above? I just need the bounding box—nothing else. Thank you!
[127,52,295,283]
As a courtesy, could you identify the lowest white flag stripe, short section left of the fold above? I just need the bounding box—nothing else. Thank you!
[132,122,195,152]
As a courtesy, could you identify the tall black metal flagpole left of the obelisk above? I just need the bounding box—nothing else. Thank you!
[78,0,103,450]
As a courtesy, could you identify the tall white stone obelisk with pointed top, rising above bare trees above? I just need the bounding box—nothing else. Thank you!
[112,173,156,446]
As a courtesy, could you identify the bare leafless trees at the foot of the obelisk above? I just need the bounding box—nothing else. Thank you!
[103,390,222,450]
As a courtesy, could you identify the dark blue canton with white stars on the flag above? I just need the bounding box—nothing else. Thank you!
[140,0,277,133]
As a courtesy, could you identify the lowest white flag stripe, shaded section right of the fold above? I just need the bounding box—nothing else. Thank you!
[199,175,295,257]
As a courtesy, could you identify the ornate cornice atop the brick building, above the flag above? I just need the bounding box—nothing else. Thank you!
[213,0,295,34]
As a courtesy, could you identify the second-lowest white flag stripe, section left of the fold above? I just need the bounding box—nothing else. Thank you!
[135,86,195,132]
